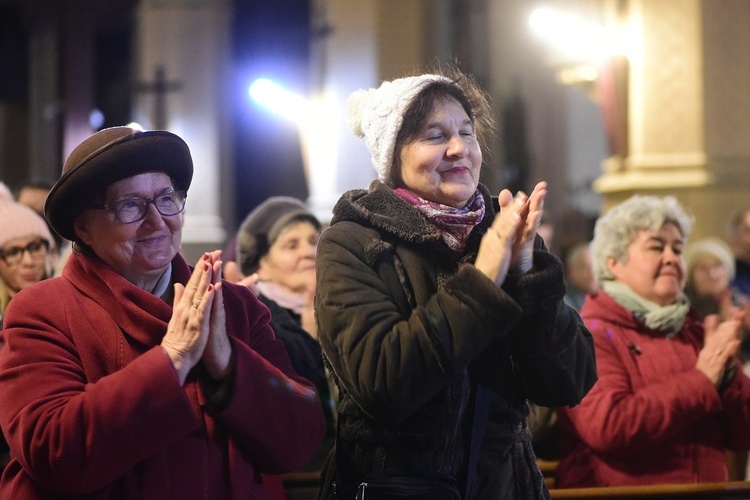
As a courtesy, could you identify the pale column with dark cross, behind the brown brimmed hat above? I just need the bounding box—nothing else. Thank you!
[134,0,232,261]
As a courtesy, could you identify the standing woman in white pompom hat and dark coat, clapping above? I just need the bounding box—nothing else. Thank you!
[315,70,596,500]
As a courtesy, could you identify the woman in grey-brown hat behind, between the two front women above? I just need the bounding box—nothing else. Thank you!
[227,196,335,471]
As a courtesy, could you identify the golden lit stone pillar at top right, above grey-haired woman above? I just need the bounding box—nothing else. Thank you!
[594,0,750,240]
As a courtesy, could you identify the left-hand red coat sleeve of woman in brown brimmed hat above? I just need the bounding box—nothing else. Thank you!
[0,287,199,494]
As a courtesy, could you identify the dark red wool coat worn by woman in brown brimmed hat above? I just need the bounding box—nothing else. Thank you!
[0,254,325,499]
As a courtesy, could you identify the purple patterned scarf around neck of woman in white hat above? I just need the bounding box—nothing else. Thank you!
[394,188,484,256]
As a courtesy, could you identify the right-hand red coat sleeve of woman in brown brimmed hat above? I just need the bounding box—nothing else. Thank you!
[206,284,325,474]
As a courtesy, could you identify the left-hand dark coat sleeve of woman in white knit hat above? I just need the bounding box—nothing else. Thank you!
[316,222,520,422]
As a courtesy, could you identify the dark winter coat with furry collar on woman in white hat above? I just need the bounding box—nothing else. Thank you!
[315,181,596,500]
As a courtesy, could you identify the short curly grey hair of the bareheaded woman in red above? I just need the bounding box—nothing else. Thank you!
[591,195,693,282]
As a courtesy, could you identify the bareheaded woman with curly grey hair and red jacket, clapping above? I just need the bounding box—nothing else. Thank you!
[556,195,750,487]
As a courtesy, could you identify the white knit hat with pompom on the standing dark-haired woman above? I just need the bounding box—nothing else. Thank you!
[346,75,452,183]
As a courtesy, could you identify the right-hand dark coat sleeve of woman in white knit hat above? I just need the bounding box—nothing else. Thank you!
[504,249,597,407]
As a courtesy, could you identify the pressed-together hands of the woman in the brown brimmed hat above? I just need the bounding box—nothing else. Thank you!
[161,250,232,384]
